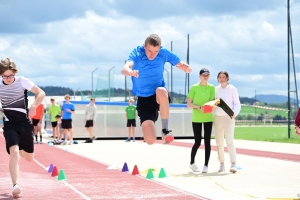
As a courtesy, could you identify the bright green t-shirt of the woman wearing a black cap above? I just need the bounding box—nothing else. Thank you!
[188,83,215,122]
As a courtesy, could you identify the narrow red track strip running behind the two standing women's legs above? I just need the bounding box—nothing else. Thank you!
[164,141,300,162]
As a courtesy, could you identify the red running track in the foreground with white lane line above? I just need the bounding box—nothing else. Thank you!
[0,133,205,200]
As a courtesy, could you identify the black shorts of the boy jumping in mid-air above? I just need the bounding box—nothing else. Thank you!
[136,94,171,124]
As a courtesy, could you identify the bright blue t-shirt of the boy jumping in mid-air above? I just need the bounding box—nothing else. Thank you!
[128,46,180,97]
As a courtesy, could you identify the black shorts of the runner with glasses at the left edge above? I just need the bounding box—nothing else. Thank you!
[3,120,34,154]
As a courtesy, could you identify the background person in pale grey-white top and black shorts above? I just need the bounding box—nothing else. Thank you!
[84,98,97,143]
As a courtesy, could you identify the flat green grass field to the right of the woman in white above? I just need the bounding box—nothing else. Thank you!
[234,125,300,144]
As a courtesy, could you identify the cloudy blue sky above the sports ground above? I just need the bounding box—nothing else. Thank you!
[0,0,300,97]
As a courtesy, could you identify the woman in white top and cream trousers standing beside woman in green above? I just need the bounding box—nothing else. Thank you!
[213,71,241,173]
